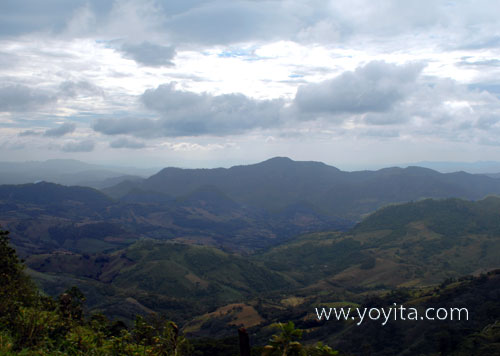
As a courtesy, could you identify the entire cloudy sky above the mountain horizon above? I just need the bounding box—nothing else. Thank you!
[0,0,500,169]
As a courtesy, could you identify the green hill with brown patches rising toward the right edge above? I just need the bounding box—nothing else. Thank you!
[255,197,500,290]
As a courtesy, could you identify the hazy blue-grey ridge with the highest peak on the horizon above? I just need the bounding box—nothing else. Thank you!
[103,157,500,221]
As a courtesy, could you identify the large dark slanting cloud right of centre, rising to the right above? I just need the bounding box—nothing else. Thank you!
[294,61,423,114]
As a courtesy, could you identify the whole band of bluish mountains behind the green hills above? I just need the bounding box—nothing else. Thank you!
[4,157,500,253]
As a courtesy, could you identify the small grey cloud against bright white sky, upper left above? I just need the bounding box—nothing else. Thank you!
[121,41,176,67]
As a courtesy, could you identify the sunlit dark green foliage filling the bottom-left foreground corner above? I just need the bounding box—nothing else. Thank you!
[0,230,193,356]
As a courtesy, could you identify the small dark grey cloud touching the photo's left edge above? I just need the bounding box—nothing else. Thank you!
[0,84,57,112]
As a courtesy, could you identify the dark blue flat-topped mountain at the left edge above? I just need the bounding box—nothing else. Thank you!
[0,182,137,256]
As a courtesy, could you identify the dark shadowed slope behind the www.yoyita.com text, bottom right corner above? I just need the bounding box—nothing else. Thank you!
[250,270,500,356]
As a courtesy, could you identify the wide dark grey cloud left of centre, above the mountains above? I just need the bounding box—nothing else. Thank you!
[93,83,283,137]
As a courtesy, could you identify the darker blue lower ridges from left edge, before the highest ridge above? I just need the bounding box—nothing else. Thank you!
[0,182,349,257]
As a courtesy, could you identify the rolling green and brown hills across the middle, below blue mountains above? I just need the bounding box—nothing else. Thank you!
[17,196,500,336]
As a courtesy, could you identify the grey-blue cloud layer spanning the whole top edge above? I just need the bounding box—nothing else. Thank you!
[0,0,500,54]
